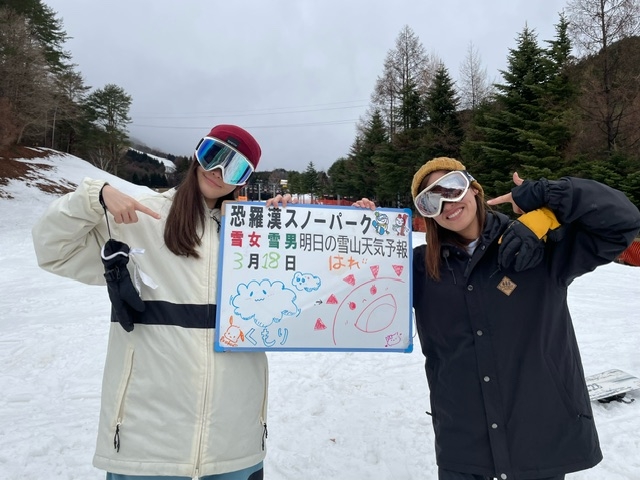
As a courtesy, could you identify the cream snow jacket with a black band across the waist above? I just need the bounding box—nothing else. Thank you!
[33,179,268,477]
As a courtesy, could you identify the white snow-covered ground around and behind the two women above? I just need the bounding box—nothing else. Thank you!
[0,155,640,480]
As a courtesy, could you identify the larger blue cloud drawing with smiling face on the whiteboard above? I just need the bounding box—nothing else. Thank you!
[231,279,300,327]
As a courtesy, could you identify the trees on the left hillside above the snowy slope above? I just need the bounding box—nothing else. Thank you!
[0,0,132,175]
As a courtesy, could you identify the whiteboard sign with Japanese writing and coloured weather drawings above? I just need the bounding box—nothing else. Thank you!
[215,202,413,352]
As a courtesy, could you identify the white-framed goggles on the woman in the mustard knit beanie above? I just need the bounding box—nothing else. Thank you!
[413,170,475,218]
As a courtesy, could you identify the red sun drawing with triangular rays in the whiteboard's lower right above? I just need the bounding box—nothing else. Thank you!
[327,265,404,345]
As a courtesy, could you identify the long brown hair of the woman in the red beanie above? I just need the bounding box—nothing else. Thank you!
[164,160,239,258]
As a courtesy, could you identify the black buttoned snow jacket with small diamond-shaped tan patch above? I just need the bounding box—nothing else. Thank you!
[413,177,640,480]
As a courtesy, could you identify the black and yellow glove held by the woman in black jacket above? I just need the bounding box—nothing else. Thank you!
[498,207,560,272]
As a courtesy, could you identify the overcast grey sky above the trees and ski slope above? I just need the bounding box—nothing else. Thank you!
[44,0,566,171]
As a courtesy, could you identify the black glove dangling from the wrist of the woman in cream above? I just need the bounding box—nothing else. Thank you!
[101,239,144,332]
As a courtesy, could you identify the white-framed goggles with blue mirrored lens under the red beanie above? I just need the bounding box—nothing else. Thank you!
[196,137,255,185]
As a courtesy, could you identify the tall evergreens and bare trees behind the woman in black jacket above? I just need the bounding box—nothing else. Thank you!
[298,0,640,207]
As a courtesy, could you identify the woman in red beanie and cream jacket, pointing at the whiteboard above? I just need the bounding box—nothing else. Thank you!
[33,125,268,480]
